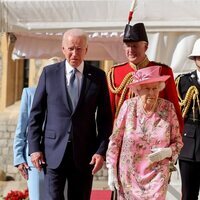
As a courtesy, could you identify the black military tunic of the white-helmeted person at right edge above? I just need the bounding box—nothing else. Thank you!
[177,71,200,161]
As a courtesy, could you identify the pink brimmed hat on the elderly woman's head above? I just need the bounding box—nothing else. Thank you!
[128,66,170,87]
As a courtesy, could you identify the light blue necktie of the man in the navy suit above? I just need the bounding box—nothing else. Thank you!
[68,68,79,111]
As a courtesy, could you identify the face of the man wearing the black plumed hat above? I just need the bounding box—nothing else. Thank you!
[124,41,148,64]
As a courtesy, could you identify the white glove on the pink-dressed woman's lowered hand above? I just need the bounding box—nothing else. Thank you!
[108,168,119,191]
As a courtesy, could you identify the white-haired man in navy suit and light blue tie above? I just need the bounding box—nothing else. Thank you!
[28,29,112,200]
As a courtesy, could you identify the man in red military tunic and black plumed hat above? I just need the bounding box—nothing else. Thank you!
[107,23,183,132]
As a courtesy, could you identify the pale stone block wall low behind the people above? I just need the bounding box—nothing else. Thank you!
[0,102,107,181]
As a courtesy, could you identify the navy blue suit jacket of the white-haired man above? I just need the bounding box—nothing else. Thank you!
[28,61,112,169]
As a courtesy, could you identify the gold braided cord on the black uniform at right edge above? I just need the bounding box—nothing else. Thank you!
[175,76,200,120]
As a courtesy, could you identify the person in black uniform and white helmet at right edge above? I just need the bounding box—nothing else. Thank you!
[176,39,200,200]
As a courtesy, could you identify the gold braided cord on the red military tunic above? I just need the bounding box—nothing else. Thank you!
[107,67,133,116]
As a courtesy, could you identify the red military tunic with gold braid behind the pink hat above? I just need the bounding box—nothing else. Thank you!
[107,57,183,133]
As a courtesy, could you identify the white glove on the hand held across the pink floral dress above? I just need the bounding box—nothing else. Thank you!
[148,147,172,163]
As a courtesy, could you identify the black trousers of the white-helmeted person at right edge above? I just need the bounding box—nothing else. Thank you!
[179,160,200,200]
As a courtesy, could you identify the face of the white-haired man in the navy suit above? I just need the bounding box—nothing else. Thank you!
[62,36,87,67]
